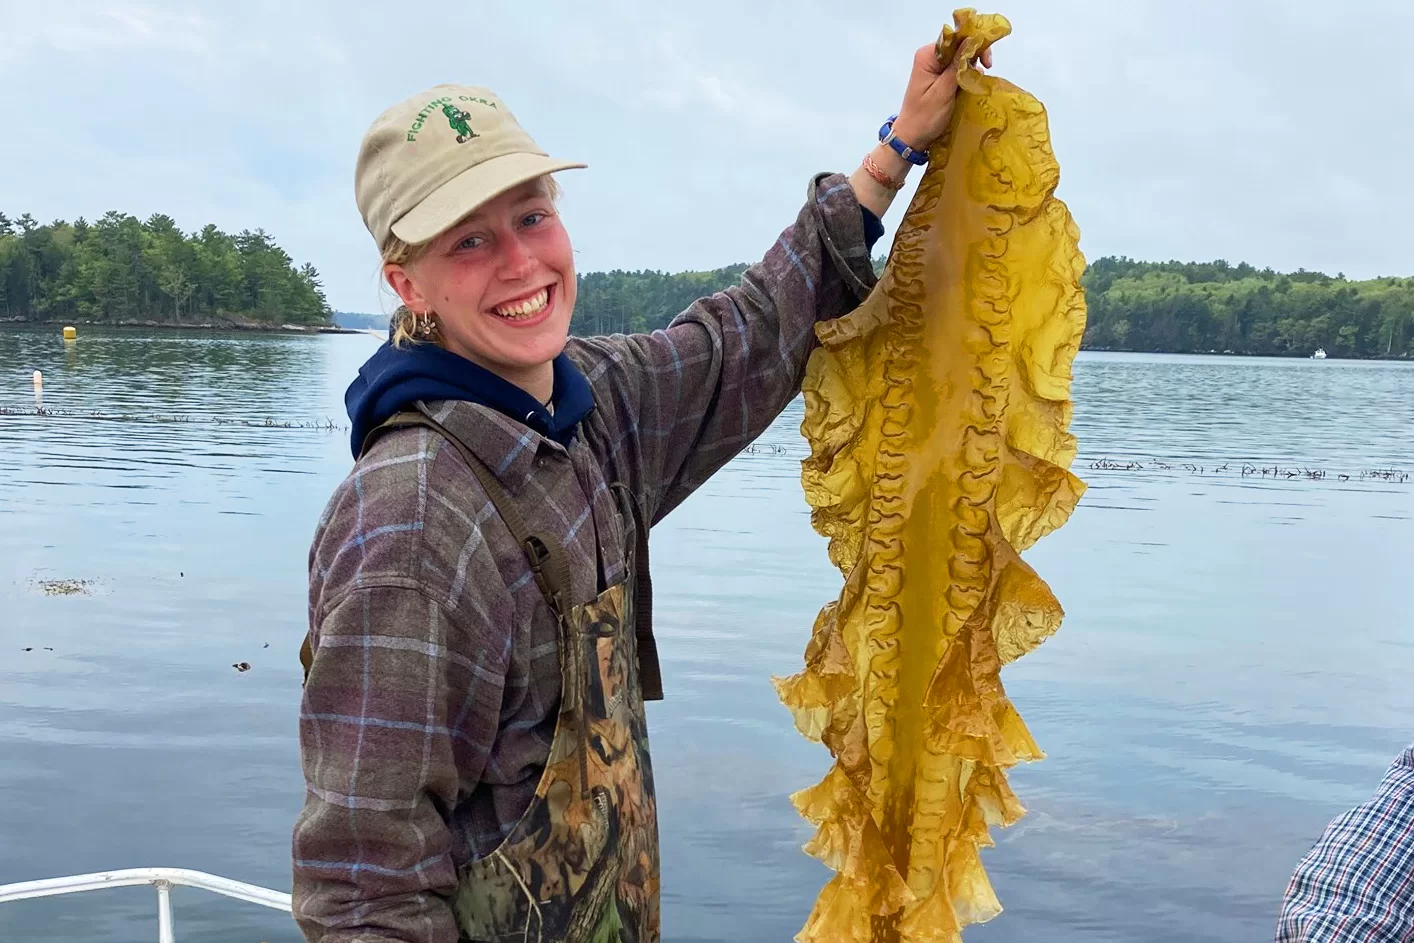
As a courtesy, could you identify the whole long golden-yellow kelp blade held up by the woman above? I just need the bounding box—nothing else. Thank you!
[776,10,1085,943]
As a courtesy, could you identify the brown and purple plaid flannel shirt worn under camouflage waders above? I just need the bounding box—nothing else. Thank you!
[293,174,874,943]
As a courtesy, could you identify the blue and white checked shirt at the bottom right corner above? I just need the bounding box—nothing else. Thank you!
[1277,746,1414,943]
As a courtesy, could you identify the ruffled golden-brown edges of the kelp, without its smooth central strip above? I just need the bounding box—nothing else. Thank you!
[773,10,1085,943]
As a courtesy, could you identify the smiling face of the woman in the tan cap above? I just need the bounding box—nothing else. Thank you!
[385,180,575,387]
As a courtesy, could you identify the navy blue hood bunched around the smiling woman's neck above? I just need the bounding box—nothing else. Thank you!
[344,344,594,459]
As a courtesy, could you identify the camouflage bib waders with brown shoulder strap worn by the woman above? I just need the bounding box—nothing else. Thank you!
[325,411,659,943]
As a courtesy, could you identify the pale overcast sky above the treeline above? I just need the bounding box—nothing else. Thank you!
[0,0,1414,311]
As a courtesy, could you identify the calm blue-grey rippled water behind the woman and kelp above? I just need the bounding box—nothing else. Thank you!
[0,329,1414,943]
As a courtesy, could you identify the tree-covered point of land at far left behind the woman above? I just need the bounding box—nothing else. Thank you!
[0,212,331,327]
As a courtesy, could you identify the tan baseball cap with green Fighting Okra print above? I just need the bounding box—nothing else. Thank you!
[354,85,588,249]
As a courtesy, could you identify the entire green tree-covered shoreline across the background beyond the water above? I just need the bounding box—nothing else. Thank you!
[0,212,1414,359]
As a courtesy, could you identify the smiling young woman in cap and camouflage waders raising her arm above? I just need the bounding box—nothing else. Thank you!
[294,36,990,943]
